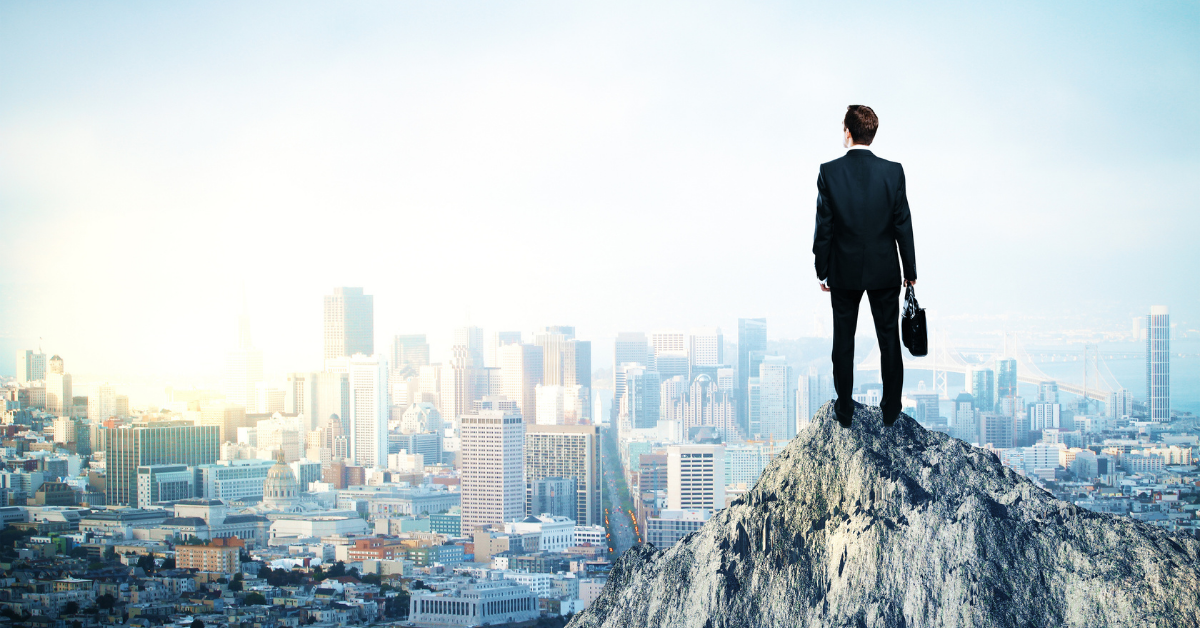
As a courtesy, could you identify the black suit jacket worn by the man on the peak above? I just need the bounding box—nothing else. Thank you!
[812,149,917,289]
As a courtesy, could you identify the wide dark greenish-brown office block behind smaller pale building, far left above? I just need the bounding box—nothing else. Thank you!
[98,421,221,508]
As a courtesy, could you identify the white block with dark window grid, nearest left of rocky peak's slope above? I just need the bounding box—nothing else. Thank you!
[667,444,725,510]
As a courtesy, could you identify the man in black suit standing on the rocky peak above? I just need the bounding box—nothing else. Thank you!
[812,104,917,427]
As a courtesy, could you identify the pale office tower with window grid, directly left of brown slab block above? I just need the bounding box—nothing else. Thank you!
[460,411,525,533]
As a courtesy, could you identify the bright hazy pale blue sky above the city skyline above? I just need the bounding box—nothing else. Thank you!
[0,1,1200,389]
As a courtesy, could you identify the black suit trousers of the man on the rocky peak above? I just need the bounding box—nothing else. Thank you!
[829,286,904,418]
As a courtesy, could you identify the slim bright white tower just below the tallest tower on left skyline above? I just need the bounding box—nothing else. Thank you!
[343,354,390,468]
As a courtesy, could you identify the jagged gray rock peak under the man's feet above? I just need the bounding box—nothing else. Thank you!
[569,405,1200,628]
